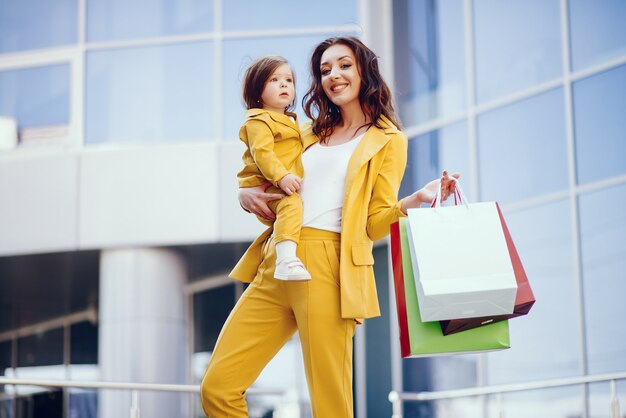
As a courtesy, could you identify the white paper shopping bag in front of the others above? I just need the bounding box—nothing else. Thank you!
[407,183,517,322]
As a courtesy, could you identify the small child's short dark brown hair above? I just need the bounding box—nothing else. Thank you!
[242,56,296,110]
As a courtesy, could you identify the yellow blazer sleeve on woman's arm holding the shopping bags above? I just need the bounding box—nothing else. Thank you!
[367,133,408,241]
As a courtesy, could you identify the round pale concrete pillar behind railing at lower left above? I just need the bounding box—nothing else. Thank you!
[98,248,189,418]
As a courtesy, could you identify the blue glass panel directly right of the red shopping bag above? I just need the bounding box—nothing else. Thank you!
[487,200,582,384]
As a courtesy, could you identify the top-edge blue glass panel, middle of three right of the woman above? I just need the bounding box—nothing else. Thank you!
[474,0,562,103]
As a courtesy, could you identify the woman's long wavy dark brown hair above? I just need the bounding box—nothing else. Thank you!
[302,36,400,142]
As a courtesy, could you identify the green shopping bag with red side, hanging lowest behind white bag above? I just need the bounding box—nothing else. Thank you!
[391,218,510,357]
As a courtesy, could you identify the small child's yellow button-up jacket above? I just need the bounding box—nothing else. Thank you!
[237,108,304,187]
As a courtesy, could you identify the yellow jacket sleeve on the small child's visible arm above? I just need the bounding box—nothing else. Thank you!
[245,119,289,187]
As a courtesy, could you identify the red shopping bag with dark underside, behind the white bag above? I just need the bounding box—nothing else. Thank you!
[440,205,535,335]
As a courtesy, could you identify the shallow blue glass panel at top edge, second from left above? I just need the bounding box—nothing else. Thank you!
[87,0,213,42]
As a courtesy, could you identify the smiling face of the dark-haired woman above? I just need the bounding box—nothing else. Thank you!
[320,44,361,107]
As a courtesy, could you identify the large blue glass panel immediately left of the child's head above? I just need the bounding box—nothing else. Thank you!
[86,42,216,143]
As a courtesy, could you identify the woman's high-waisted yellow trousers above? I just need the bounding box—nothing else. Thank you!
[201,228,356,418]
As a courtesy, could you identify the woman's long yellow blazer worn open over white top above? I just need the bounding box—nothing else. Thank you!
[230,116,408,321]
